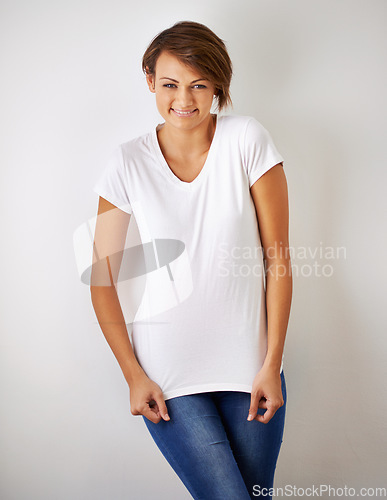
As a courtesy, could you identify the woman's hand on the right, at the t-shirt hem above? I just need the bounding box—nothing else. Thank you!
[247,366,284,424]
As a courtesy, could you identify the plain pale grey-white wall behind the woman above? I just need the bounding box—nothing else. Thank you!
[0,0,387,500]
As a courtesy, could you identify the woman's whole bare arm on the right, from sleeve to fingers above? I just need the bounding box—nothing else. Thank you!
[250,163,293,423]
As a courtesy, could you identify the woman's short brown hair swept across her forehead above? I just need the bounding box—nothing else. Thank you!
[142,21,233,111]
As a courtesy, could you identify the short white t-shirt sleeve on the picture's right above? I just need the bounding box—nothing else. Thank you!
[243,117,284,187]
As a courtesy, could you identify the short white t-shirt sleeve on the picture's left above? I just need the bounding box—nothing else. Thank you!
[93,146,132,214]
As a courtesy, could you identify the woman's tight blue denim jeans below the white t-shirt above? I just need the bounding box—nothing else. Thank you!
[142,371,287,500]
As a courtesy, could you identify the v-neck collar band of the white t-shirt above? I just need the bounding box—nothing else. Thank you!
[150,115,222,189]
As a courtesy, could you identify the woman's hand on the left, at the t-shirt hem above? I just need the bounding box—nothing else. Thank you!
[129,373,170,424]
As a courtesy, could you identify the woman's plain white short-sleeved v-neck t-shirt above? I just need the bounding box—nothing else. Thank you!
[93,115,284,400]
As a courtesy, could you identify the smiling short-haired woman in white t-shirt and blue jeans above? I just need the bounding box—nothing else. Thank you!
[91,21,292,500]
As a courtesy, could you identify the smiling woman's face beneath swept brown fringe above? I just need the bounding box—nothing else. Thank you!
[147,52,215,130]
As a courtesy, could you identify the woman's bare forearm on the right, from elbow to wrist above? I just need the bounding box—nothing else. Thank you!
[264,258,293,371]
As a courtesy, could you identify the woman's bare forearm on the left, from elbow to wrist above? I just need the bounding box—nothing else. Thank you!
[90,286,144,385]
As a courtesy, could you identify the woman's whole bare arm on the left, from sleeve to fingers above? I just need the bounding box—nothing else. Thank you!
[90,197,171,423]
